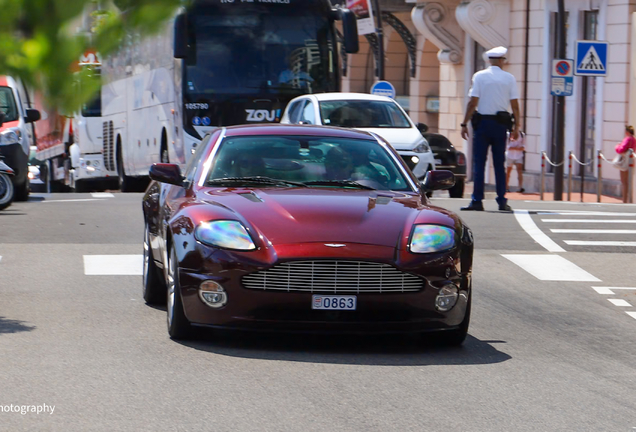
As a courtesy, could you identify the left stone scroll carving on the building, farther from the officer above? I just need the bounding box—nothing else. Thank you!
[411,1,464,64]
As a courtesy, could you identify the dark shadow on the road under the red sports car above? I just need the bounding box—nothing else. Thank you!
[175,330,511,366]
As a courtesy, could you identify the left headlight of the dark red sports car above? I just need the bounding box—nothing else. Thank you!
[194,220,256,251]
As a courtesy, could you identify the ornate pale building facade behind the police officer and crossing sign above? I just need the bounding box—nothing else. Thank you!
[343,0,636,196]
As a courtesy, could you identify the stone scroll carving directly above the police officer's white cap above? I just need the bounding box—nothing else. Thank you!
[455,0,510,49]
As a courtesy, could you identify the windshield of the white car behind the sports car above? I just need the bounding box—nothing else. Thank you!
[320,100,411,128]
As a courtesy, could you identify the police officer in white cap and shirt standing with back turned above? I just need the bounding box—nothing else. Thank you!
[461,47,520,211]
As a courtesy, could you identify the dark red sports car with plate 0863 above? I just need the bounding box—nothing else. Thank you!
[143,125,473,344]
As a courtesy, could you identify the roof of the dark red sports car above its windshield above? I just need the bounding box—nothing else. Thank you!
[225,124,375,140]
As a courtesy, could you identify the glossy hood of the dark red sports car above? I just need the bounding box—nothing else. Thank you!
[199,188,457,247]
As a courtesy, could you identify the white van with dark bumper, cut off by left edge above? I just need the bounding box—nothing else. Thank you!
[0,75,40,201]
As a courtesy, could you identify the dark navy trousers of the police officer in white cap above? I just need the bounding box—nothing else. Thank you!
[472,115,508,205]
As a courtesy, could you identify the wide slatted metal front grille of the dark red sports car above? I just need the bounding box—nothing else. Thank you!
[243,261,424,294]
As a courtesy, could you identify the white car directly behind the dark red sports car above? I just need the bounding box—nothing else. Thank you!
[280,93,435,179]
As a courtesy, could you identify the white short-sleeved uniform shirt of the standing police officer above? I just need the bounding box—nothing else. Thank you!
[468,66,519,115]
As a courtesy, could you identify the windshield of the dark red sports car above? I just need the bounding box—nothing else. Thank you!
[206,136,412,191]
